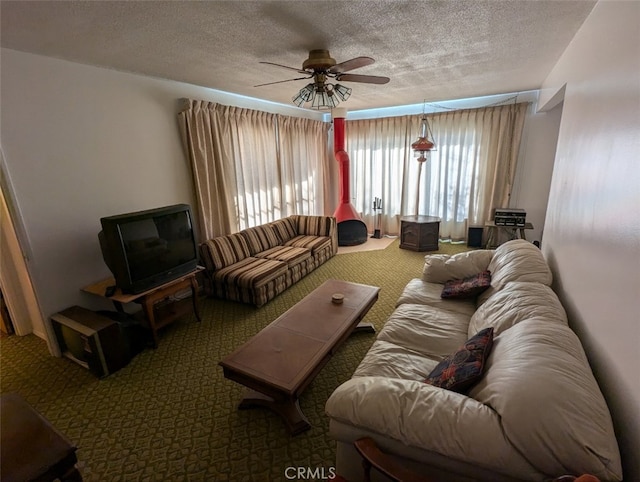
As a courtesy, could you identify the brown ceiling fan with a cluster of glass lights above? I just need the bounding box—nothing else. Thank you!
[255,49,390,109]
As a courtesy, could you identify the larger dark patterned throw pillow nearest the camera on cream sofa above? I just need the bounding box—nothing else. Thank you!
[425,327,493,393]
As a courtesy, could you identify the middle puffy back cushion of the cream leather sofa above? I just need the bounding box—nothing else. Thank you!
[468,281,568,336]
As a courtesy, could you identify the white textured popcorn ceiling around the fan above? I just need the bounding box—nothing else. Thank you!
[0,0,596,110]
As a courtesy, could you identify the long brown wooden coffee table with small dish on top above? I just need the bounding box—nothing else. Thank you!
[220,279,380,435]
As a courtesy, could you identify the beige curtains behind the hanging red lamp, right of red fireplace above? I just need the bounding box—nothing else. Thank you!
[346,103,528,241]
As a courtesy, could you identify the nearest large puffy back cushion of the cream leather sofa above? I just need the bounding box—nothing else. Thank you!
[469,319,622,480]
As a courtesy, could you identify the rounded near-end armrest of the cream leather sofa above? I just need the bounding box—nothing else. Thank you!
[325,377,535,473]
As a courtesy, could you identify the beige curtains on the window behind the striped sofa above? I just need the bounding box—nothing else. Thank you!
[178,100,329,240]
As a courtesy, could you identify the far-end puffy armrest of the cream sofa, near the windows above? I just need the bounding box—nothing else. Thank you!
[422,249,494,283]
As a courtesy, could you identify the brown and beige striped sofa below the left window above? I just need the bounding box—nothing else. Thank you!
[200,215,338,307]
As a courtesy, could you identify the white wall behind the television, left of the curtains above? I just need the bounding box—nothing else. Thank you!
[0,49,322,332]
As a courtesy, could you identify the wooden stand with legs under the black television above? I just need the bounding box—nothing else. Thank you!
[82,266,204,348]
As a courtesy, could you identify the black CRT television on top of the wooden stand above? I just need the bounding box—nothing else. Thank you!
[98,204,198,294]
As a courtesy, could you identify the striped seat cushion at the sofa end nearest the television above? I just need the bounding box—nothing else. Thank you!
[214,257,287,288]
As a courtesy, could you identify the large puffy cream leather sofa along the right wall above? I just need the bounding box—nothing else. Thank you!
[326,240,622,482]
